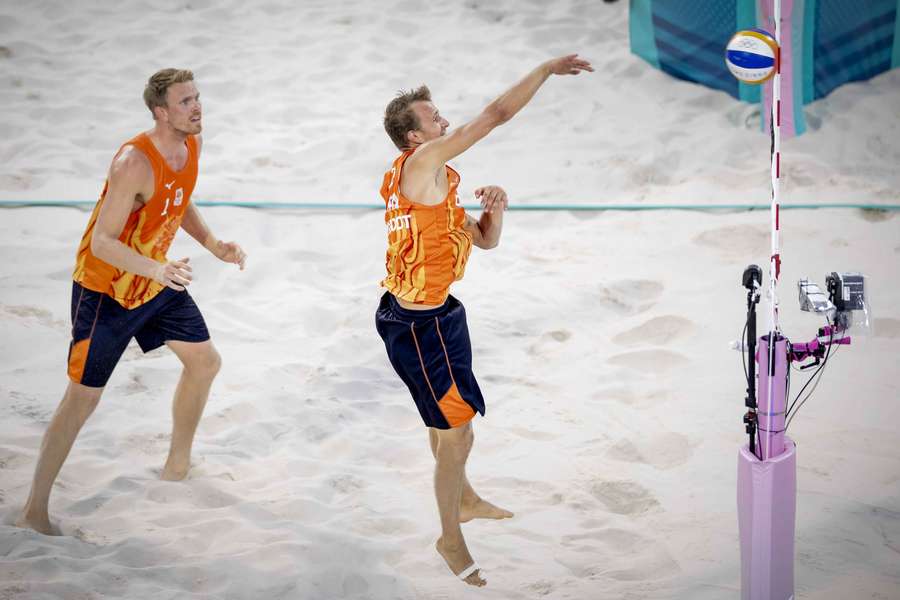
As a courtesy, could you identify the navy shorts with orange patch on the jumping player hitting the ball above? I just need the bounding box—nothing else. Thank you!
[375,292,484,429]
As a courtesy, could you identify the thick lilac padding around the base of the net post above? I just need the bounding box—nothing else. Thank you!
[737,438,797,600]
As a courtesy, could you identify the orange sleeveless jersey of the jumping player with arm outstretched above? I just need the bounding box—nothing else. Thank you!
[381,150,472,304]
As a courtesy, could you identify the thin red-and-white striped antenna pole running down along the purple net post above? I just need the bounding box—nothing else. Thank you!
[765,0,781,458]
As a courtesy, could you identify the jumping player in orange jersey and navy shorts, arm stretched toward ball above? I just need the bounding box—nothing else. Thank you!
[375,54,593,587]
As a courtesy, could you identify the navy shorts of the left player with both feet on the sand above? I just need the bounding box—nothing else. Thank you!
[69,281,209,387]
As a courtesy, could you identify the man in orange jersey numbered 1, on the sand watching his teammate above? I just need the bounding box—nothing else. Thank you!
[16,69,246,534]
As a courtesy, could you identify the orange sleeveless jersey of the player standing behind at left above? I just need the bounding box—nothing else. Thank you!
[72,133,197,308]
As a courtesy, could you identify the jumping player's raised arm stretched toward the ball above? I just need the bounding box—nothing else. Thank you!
[414,54,594,168]
